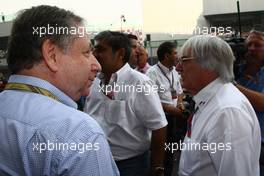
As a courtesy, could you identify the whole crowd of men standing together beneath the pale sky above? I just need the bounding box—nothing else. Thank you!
[0,5,264,176]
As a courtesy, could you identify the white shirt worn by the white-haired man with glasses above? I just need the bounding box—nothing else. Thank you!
[179,78,261,176]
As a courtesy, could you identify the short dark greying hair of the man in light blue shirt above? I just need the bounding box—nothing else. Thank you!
[7,5,84,73]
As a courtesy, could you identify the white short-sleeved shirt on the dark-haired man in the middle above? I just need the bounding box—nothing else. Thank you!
[84,64,167,160]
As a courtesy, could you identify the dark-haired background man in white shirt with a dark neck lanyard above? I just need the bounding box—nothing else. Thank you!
[146,42,186,176]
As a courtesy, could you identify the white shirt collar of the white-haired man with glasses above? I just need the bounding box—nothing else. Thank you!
[193,78,224,110]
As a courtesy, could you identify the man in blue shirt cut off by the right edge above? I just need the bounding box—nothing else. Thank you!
[235,30,264,176]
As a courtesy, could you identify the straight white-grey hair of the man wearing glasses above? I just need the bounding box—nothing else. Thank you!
[180,35,235,82]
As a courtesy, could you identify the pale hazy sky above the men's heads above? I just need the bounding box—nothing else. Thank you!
[0,0,202,33]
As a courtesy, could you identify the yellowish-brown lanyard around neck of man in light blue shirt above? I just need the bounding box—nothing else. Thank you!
[5,83,59,101]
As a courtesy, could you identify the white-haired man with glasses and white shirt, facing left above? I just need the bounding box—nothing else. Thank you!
[176,35,261,176]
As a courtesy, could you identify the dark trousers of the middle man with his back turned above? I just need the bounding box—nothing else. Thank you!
[116,151,150,176]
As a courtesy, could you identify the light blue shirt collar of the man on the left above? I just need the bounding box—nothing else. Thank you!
[8,75,77,109]
